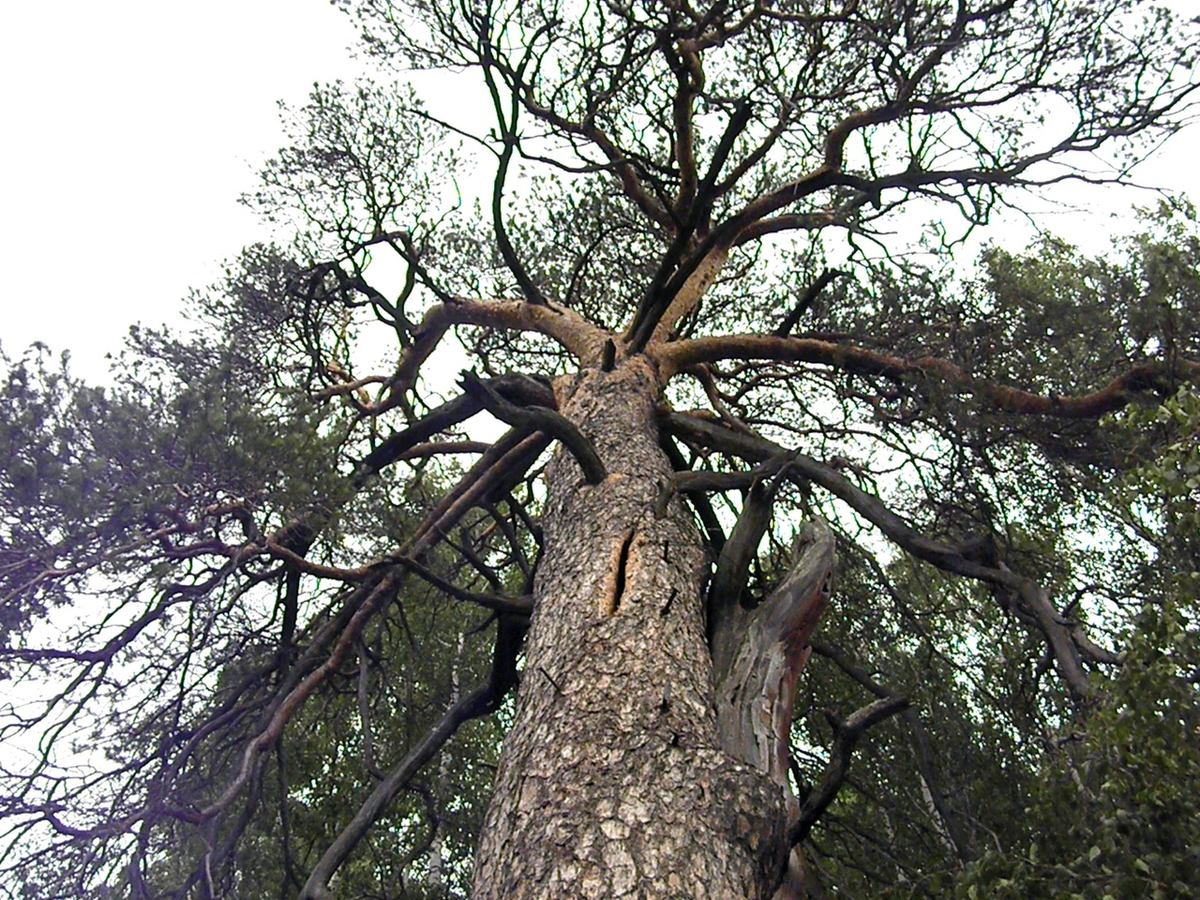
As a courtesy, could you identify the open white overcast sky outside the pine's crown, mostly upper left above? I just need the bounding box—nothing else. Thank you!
[0,0,1200,377]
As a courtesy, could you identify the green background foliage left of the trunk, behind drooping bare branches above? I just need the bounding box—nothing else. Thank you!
[216,584,503,900]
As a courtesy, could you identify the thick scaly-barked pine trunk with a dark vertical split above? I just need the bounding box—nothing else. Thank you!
[474,358,787,900]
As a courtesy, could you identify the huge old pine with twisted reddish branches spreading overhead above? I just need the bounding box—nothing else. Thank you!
[0,0,1200,899]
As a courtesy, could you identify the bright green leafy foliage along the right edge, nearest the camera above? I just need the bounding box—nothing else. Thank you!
[955,312,1200,900]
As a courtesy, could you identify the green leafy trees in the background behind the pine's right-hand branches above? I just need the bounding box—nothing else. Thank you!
[772,209,1200,898]
